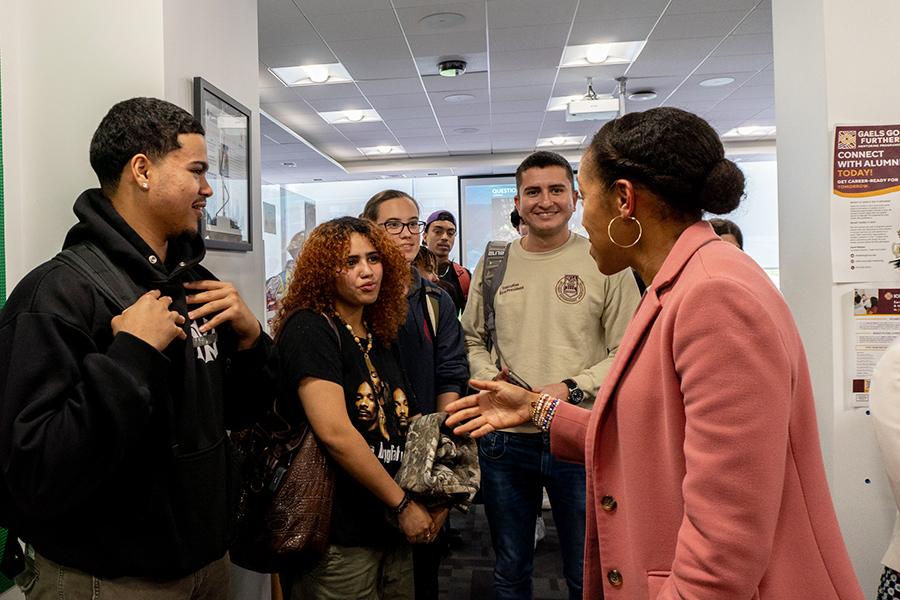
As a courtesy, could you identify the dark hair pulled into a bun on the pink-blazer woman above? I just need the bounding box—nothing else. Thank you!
[585,106,744,221]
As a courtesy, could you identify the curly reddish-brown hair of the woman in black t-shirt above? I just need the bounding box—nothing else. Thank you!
[275,217,410,343]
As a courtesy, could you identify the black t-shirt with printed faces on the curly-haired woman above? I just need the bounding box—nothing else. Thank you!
[277,310,415,546]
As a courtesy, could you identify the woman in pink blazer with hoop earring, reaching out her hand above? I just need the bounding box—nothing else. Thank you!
[449,108,863,600]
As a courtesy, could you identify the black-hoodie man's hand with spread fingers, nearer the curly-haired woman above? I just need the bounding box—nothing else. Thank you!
[184,280,262,350]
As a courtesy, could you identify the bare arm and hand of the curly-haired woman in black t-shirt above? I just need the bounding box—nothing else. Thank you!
[297,377,432,543]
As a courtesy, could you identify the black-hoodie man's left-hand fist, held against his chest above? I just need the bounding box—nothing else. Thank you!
[110,290,187,352]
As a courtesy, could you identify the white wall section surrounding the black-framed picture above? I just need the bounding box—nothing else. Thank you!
[162,0,265,320]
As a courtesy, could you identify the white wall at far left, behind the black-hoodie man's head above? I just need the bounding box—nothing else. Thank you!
[0,0,163,291]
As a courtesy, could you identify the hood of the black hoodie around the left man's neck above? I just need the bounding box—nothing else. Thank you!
[63,188,206,287]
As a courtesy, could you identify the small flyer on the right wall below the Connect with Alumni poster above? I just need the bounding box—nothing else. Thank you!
[847,287,900,408]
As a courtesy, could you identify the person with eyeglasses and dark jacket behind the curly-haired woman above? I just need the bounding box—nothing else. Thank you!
[362,190,469,600]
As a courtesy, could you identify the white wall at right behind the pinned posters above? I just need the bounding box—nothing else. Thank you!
[773,0,900,597]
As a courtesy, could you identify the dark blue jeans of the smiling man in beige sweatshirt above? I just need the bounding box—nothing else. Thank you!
[478,431,585,600]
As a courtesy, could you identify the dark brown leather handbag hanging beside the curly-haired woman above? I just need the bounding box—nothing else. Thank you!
[230,407,334,573]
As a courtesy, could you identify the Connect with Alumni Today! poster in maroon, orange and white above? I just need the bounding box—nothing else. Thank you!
[831,125,900,283]
